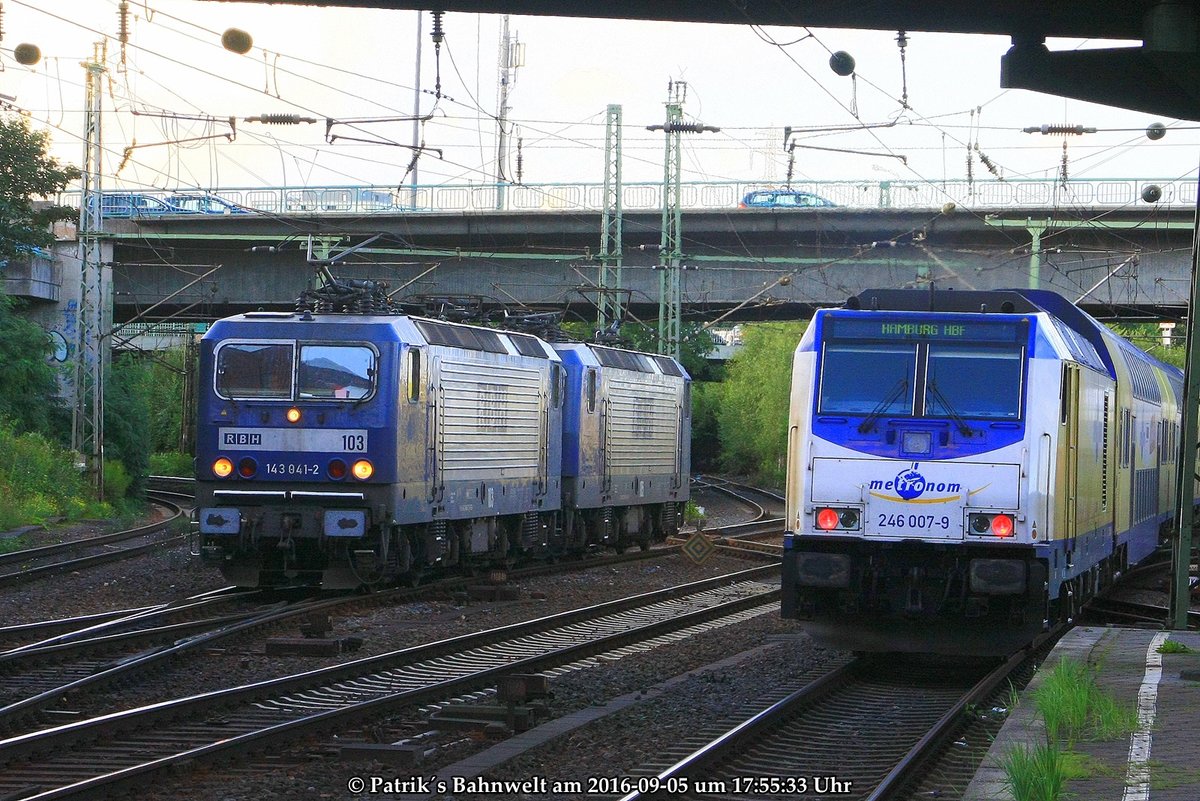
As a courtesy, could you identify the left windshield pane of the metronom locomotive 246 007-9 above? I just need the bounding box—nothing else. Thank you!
[818,342,917,415]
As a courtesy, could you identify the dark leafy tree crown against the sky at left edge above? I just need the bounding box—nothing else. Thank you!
[0,116,79,259]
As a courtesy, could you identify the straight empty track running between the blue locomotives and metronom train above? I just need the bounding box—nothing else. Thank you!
[0,566,779,800]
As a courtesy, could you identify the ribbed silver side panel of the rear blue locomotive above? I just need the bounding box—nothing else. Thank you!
[605,371,679,475]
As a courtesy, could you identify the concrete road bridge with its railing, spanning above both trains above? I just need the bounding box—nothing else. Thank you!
[79,180,1196,321]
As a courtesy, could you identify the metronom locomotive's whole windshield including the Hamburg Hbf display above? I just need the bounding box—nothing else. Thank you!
[817,317,1027,420]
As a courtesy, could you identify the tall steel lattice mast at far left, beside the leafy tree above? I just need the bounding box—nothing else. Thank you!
[71,43,108,498]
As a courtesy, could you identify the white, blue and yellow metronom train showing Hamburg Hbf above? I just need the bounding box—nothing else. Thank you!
[782,289,1182,655]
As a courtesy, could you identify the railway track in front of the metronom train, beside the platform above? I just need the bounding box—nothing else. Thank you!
[620,642,1049,801]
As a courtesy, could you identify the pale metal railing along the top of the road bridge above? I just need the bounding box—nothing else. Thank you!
[59,179,1196,216]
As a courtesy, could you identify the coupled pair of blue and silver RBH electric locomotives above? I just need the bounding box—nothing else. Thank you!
[197,312,690,589]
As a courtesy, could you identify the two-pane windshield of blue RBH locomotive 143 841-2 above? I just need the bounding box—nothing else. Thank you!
[216,342,377,401]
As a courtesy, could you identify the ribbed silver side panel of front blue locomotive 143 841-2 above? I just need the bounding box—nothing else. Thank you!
[438,361,546,481]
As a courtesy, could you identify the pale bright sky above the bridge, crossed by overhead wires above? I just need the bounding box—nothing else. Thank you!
[0,0,1200,195]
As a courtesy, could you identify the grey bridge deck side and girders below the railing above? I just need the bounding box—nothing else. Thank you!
[106,207,1192,320]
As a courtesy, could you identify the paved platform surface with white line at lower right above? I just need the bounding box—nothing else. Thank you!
[962,627,1200,801]
